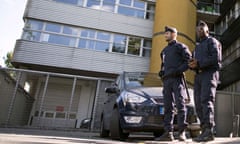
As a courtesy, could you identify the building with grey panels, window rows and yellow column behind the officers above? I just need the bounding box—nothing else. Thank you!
[9,0,240,128]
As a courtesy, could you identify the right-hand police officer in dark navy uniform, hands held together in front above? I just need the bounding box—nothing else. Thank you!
[189,21,222,142]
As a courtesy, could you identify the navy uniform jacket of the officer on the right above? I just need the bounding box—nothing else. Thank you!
[193,37,222,71]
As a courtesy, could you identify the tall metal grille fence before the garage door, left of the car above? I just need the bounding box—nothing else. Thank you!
[0,68,112,129]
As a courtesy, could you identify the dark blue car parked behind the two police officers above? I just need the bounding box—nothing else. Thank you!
[100,72,200,140]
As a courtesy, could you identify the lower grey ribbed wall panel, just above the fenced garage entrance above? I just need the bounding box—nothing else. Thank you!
[13,40,149,73]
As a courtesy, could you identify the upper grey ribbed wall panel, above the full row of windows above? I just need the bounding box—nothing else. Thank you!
[24,0,153,38]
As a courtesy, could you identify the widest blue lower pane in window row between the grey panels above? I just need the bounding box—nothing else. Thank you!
[42,34,76,47]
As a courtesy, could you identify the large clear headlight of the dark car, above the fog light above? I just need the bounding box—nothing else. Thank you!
[123,92,147,105]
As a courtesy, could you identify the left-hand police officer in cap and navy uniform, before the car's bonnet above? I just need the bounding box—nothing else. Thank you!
[156,26,191,141]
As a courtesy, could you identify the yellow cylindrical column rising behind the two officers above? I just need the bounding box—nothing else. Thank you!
[150,0,196,82]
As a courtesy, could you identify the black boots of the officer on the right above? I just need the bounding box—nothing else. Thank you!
[193,128,214,142]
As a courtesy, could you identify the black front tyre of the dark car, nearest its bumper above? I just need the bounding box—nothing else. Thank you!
[110,109,129,140]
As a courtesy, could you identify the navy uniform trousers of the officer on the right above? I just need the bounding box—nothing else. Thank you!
[194,70,219,128]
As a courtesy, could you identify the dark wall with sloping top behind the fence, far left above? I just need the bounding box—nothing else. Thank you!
[0,70,34,126]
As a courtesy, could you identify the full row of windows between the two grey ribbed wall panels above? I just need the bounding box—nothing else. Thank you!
[22,20,152,57]
